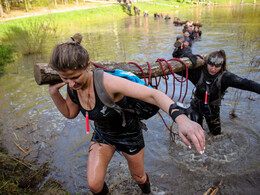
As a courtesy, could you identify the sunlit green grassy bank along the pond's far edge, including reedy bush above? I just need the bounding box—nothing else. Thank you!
[0,0,254,66]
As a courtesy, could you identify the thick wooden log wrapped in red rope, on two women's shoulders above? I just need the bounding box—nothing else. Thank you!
[34,57,205,85]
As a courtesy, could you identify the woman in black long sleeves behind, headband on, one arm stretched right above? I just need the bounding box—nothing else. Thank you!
[178,50,260,135]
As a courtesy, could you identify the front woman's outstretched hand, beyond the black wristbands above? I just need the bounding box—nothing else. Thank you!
[175,114,205,154]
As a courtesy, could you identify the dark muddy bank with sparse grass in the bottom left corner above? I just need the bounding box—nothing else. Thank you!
[0,137,68,195]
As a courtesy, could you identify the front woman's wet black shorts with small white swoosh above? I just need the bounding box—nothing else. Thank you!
[91,130,145,155]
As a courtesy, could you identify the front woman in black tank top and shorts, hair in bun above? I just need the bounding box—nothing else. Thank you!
[49,33,205,194]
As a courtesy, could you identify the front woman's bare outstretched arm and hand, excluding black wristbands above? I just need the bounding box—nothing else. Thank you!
[104,73,205,153]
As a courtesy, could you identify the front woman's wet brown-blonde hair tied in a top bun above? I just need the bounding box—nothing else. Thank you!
[50,33,89,71]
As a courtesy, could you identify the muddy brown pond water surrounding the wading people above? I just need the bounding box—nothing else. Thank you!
[0,5,260,194]
